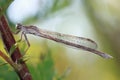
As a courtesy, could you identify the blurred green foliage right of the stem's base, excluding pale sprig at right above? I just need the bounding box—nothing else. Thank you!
[28,48,55,80]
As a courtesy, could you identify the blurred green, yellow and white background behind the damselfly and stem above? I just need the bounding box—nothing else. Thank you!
[0,0,120,80]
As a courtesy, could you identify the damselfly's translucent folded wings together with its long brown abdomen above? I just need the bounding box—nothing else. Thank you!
[37,29,112,58]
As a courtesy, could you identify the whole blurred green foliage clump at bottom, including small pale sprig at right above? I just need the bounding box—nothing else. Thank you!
[28,49,70,80]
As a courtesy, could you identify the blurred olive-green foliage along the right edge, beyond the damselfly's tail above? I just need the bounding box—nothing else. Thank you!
[83,0,120,80]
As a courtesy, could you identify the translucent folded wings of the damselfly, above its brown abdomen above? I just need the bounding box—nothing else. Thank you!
[39,30,97,49]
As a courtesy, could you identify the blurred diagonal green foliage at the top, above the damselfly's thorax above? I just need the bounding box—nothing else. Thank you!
[23,0,72,24]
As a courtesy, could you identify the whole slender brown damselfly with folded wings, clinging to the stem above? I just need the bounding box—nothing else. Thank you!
[16,23,112,59]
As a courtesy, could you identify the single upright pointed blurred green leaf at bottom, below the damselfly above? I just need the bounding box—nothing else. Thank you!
[38,50,55,80]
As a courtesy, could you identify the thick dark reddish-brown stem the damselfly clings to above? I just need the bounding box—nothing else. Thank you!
[0,13,32,80]
